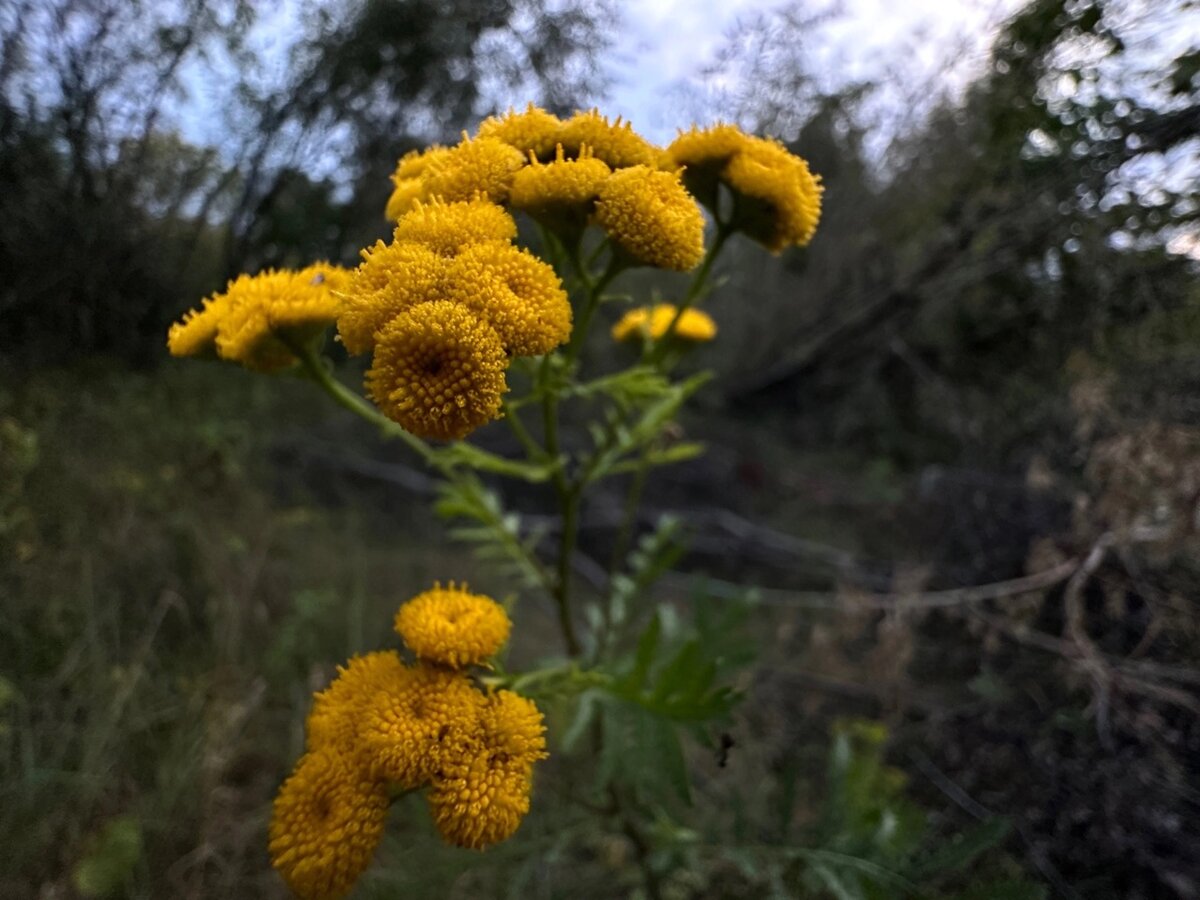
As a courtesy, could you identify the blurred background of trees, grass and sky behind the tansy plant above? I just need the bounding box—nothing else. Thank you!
[0,0,1200,899]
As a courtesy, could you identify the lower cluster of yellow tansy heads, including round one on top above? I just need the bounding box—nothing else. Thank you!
[270,583,546,900]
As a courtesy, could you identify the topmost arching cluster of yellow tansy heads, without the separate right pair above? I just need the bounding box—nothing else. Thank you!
[386,104,704,271]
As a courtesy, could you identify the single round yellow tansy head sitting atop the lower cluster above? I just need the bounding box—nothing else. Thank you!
[396,582,511,668]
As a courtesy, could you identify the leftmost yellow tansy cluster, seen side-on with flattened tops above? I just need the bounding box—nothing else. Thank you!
[167,263,348,372]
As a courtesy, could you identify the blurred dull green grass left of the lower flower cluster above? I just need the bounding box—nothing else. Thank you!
[0,366,492,898]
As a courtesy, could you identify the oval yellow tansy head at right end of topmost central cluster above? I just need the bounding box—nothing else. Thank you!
[595,166,704,271]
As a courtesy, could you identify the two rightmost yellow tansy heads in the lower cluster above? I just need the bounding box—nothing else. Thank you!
[430,691,546,850]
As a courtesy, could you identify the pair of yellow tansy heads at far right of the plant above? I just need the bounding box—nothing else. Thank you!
[666,125,821,253]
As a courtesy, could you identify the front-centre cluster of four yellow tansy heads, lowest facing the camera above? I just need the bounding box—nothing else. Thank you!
[337,196,571,440]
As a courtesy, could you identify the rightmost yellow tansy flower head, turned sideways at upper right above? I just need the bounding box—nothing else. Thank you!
[724,138,821,253]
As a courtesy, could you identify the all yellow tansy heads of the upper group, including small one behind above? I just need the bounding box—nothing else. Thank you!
[168,104,821,440]
